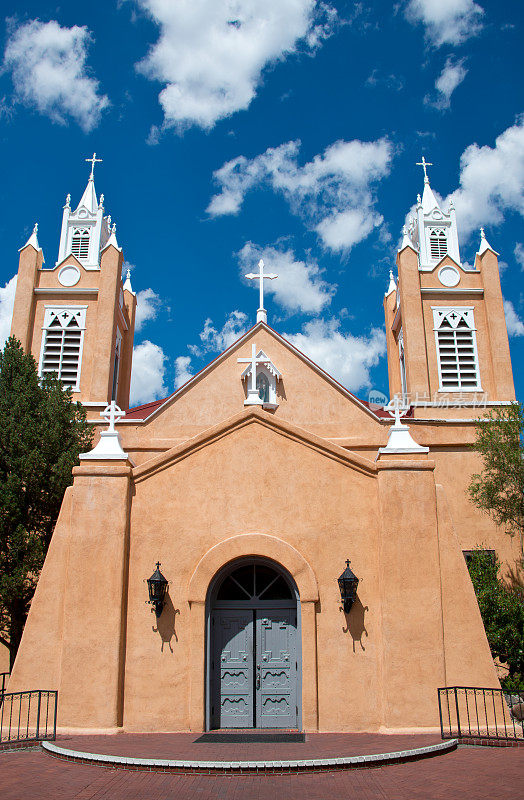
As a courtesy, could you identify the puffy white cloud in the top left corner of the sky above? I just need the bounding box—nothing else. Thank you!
[3,19,109,131]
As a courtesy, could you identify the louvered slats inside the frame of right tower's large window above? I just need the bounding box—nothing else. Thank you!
[437,319,479,391]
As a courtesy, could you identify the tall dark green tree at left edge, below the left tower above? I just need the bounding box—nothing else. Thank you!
[0,337,92,666]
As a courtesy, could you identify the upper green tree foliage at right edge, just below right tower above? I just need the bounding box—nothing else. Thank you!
[469,403,524,561]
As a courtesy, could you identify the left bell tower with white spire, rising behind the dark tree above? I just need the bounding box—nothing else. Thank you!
[11,153,136,410]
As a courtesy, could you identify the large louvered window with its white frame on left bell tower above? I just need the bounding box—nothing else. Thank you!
[39,306,86,392]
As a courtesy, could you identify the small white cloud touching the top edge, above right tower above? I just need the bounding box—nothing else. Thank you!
[404,0,484,47]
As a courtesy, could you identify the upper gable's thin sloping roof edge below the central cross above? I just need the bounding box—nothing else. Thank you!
[125,322,391,422]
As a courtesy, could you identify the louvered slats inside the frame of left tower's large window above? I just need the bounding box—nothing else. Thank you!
[41,317,83,389]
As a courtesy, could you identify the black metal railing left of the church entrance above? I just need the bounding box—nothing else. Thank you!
[0,689,58,746]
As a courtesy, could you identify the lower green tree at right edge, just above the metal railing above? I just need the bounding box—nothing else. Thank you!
[468,550,524,691]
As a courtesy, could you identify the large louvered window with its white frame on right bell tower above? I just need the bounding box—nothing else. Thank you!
[433,308,481,392]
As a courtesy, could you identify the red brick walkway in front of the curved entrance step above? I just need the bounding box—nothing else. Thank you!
[0,747,524,800]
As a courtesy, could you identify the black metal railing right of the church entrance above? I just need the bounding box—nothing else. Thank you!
[438,686,524,741]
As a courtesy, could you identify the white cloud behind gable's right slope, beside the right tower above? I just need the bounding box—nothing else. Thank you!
[284,318,386,391]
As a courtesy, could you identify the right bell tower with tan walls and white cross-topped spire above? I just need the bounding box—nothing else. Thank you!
[384,158,515,407]
